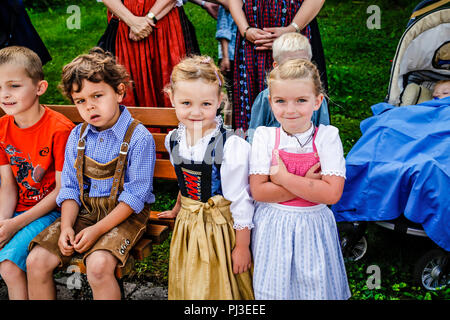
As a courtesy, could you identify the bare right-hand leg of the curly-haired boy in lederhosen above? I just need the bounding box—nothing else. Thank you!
[86,250,121,300]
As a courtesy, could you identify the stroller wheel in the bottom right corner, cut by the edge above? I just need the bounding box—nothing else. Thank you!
[414,249,450,290]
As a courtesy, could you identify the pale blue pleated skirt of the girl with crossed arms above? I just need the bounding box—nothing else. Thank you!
[251,203,351,300]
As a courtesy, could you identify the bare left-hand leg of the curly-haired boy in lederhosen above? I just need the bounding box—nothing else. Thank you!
[27,245,60,300]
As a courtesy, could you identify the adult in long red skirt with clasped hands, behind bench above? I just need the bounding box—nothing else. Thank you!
[103,0,186,107]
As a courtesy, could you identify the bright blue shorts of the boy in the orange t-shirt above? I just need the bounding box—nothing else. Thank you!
[0,211,61,272]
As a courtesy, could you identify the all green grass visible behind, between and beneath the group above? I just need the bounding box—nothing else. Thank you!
[22,0,450,300]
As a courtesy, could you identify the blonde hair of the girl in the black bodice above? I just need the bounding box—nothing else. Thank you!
[164,55,224,92]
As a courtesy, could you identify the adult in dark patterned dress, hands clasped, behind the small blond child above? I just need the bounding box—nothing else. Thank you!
[229,0,326,131]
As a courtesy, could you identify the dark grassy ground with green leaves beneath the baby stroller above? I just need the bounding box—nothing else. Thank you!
[345,224,450,300]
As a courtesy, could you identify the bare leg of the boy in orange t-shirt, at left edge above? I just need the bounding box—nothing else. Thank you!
[0,260,28,300]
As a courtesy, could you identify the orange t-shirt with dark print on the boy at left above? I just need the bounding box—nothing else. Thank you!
[0,106,75,211]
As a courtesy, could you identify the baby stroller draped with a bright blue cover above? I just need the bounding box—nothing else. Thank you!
[332,0,450,290]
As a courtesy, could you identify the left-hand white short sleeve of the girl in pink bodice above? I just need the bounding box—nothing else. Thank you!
[249,127,275,175]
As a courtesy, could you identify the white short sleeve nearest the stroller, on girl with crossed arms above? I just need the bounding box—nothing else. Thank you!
[316,124,345,178]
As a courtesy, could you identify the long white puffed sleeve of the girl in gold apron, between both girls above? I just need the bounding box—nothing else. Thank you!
[220,136,255,230]
